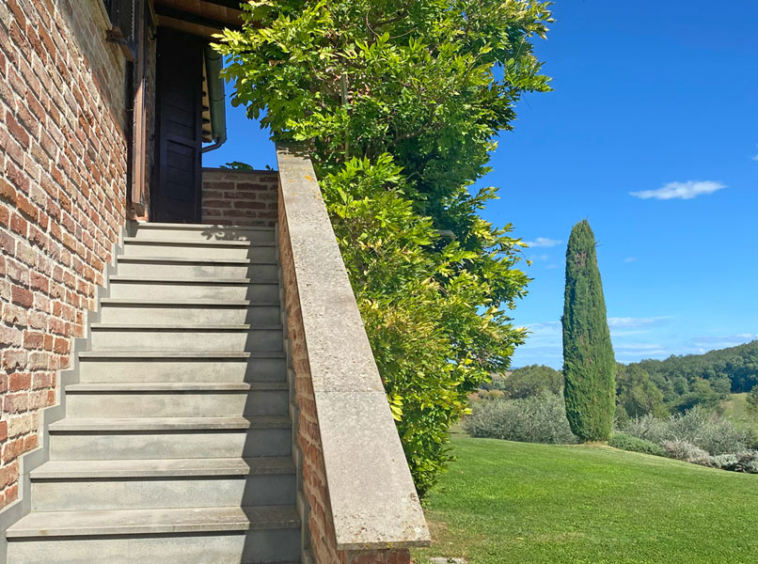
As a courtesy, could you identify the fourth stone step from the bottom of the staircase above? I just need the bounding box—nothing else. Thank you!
[66,382,289,418]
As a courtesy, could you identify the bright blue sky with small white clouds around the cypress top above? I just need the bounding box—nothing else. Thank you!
[205,0,758,368]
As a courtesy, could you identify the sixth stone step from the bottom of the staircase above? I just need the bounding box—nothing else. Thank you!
[90,323,284,352]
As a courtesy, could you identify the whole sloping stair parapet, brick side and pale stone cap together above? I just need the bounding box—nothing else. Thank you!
[277,147,430,564]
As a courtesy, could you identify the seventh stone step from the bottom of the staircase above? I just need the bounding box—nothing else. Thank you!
[100,298,282,325]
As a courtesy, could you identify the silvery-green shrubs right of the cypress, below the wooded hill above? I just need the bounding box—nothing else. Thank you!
[619,406,750,455]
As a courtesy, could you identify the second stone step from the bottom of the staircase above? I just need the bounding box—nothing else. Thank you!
[31,457,296,511]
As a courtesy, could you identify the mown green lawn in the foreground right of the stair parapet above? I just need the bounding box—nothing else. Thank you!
[413,437,758,564]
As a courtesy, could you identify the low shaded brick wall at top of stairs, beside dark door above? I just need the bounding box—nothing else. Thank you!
[202,168,279,227]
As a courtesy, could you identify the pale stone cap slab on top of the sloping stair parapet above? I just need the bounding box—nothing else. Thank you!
[277,146,430,550]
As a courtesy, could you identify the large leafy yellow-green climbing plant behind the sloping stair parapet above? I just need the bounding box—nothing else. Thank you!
[216,0,551,494]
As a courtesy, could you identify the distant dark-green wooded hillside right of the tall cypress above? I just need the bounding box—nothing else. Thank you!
[625,341,758,410]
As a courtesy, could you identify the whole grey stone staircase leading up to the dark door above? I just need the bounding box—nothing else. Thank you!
[7,224,301,564]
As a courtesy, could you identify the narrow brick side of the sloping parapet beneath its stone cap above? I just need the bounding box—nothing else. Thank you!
[278,177,410,564]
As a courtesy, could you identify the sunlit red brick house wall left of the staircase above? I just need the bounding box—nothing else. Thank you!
[0,0,126,508]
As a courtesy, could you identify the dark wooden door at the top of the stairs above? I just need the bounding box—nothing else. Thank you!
[151,28,205,223]
